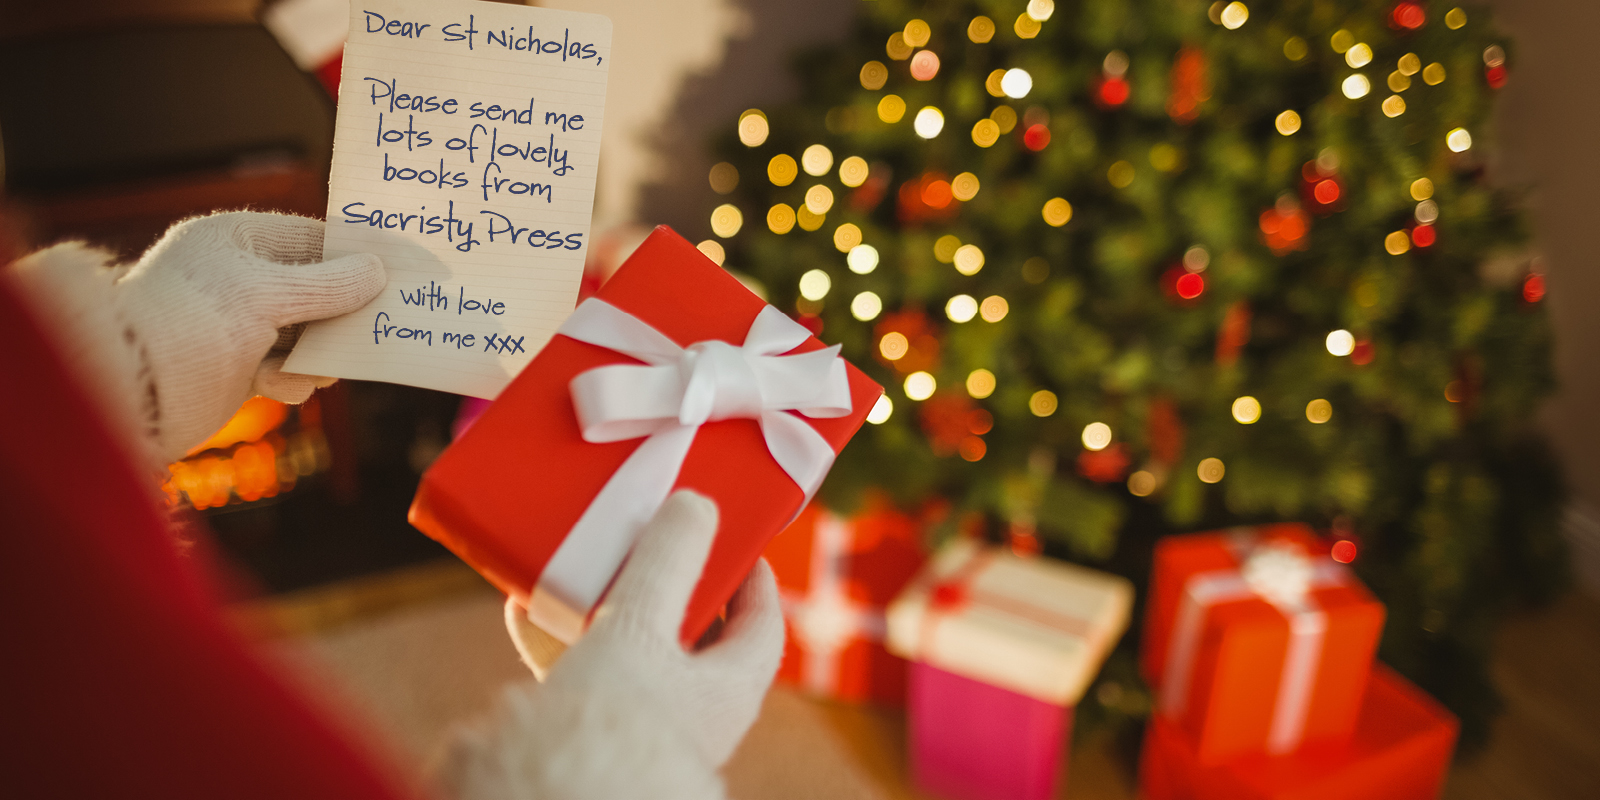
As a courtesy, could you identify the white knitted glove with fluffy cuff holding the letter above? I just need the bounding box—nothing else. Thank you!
[18,211,386,461]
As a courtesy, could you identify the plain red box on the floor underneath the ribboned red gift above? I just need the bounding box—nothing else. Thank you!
[1139,664,1458,800]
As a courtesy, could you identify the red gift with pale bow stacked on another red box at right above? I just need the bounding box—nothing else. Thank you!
[1141,525,1384,763]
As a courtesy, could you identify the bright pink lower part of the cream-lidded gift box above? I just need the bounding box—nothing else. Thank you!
[907,662,1072,800]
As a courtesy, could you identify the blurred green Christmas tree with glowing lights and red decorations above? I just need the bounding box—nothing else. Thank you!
[701,0,1565,739]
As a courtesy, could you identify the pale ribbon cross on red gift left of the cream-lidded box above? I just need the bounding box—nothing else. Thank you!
[782,512,888,696]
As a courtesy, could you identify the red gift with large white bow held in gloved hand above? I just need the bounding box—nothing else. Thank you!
[411,227,883,642]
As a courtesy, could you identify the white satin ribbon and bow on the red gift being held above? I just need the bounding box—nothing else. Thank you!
[528,298,851,643]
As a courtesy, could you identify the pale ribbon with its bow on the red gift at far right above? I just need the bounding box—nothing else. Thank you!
[1162,534,1349,754]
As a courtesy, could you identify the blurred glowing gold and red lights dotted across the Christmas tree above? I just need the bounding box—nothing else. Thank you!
[698,0,1510,496]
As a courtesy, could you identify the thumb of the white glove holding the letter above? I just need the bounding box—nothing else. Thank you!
[256,253,389,328]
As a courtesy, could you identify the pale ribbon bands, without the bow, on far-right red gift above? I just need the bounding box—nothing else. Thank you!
[1160,540,1349,754]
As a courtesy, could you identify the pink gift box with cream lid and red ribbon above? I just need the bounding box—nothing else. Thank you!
[888,539,1133,800]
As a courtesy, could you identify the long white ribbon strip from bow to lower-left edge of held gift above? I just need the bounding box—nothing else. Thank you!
[528,426,698,643]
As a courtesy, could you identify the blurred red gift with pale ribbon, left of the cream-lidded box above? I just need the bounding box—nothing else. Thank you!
[766,493,926,706]
